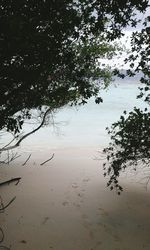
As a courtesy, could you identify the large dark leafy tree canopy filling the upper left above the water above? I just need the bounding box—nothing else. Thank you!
[0,0,148,133]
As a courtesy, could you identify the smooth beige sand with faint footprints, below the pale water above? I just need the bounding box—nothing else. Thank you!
[0,148,150,250]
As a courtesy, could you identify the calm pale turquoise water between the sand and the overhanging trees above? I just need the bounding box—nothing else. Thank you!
[23,81,145,151]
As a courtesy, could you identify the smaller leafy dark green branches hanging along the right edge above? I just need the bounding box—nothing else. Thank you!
[103,12,150,194]
